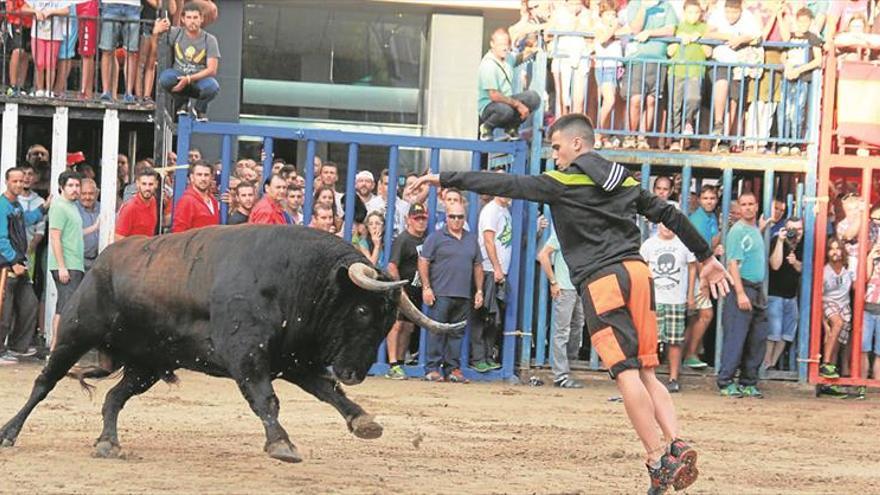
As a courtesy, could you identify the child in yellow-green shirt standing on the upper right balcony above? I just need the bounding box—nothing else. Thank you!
[667,0,712,151]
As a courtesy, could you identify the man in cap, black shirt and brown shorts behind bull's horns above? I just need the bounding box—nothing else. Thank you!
[385,203,428,380]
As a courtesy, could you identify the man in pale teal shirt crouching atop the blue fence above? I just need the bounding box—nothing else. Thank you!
[477,28,541,140]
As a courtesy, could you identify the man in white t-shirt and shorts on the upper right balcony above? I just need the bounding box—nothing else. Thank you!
[704,0,763,152]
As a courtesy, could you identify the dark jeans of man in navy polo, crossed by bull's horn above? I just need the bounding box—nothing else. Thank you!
[425,296,473,373]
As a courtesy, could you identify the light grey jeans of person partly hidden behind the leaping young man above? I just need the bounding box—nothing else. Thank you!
[550,289,584,380]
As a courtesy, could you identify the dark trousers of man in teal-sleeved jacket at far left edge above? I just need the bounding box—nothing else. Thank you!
[0,278,39,354]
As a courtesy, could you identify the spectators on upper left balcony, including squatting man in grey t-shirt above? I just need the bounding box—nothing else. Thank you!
[0,0,220,118]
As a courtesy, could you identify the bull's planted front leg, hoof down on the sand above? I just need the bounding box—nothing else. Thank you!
[231,363,302,462]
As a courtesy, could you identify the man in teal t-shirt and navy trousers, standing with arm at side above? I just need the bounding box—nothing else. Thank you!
[717,192,769,398]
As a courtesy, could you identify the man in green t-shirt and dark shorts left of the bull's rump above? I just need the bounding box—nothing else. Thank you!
[49,171,85,350]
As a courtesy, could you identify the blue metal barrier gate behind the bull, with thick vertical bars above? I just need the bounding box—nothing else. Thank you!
[174,117,534,380]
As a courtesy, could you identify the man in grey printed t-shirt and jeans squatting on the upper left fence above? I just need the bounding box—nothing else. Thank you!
[153,3,220,121]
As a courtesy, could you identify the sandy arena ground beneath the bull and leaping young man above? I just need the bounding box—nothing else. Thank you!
[0,365,880,495]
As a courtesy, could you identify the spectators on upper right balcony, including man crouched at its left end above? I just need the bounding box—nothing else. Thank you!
[492,0,880,155]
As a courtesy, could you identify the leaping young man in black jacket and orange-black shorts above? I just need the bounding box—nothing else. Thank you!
[410,114,730,494]
